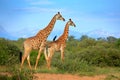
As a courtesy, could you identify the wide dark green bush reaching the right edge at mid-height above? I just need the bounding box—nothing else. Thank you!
[77,47,120,67]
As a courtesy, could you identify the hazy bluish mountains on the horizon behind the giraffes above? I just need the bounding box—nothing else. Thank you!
[0,26,120,40]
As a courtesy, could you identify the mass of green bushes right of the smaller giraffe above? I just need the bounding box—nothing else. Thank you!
[48,35,120,73]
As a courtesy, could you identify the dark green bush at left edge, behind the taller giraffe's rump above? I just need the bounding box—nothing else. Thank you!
[0,39,20,65]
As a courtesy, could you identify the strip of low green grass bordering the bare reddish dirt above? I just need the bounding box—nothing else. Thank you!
[0,64,120,80]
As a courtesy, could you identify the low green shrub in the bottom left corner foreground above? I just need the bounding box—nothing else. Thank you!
[0,65,33,80]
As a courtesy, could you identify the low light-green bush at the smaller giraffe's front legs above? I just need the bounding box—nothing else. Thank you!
[52,54,94,73]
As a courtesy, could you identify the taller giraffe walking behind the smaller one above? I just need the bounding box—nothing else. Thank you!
[21,12,65,69]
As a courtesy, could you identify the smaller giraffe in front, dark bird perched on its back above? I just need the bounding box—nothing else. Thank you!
[44,19,76,69]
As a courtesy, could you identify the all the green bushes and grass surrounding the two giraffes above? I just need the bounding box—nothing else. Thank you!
[0,35,120,80]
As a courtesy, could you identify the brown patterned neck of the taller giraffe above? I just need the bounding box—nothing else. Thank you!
[36,16,56,37]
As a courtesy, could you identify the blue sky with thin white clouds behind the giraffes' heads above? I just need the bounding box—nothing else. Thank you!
[0,0,120,38]
